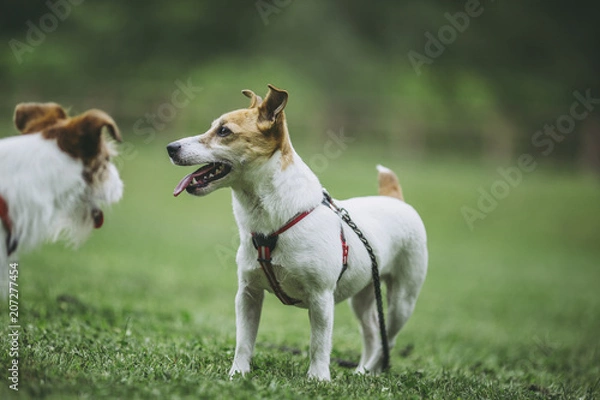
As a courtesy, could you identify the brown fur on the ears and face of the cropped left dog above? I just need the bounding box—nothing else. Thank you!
[15,103,122,183]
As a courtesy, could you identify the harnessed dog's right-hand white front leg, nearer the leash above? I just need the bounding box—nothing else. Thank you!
[308,292,335,381]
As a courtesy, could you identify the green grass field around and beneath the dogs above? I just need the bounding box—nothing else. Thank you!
[0,138,600,399]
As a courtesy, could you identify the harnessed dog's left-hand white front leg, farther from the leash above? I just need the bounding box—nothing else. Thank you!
[229,282,264,376]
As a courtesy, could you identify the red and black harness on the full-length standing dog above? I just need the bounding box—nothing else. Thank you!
[252,195,348,306]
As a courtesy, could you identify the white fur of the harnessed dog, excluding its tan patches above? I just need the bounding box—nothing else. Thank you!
[172,119,427,380]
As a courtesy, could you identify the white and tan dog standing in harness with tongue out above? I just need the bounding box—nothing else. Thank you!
[167,85,427,380]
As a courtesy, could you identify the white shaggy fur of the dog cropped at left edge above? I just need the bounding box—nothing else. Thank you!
[0,133,123,289]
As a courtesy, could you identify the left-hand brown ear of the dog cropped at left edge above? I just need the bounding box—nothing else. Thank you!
[13,103,67,133]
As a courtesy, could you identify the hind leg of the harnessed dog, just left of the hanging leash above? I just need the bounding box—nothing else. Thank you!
[350,283,379,373]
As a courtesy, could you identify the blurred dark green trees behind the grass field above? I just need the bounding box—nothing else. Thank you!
[0,0,600,170]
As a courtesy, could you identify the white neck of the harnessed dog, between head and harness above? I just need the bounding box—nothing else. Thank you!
[232,146,323,233]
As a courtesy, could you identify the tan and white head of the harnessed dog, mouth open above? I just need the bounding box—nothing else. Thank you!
[167,85,292,196]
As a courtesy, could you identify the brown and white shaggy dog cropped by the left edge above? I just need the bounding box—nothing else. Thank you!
[0,103,123,292]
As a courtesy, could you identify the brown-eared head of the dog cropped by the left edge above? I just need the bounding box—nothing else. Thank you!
[14,103,123,228]
